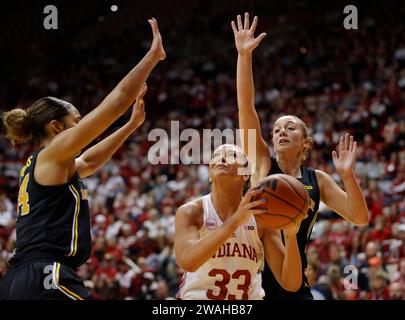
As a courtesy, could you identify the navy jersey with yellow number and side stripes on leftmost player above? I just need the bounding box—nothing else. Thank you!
[10,150,91,268]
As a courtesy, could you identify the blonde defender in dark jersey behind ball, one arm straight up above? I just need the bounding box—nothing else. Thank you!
[231,13,368,299]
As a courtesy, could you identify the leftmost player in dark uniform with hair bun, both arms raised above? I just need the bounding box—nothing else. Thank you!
[0,19,166,300]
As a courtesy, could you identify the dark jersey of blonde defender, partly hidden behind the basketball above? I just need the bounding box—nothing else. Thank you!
[263,158,320,299]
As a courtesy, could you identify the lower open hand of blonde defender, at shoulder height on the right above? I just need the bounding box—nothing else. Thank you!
[332,133,357,178]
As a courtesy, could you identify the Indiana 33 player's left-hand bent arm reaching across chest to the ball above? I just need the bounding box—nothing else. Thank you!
[174,190,263,272]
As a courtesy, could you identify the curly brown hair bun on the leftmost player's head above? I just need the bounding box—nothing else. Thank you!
[2,108,32,144]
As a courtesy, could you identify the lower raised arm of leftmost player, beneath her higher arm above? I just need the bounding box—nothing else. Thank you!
[75,83,148,179]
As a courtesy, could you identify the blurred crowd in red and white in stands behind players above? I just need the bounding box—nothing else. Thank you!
[0,0,405,300]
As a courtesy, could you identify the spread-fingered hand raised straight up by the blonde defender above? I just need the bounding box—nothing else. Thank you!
[231,13,267,54]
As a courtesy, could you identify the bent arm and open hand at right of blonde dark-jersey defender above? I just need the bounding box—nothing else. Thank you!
[316,134,369,226]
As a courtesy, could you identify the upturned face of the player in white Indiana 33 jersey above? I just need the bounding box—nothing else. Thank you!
[209,145,247,175]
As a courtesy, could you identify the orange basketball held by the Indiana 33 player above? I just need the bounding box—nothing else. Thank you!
[255,174,310,229]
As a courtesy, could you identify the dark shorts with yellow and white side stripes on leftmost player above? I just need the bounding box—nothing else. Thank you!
[0,259,91,300]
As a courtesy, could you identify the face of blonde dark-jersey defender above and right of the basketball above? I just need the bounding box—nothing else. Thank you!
[273,116,304,152]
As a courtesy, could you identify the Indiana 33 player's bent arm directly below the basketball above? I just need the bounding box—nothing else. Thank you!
[262,215,307,292]
